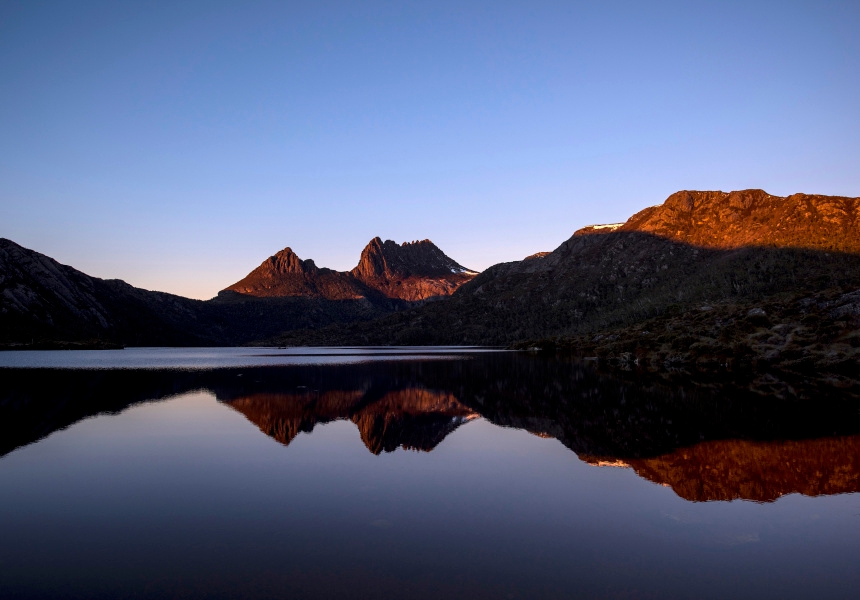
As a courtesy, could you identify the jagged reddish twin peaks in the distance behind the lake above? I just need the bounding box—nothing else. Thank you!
[222,237,477,304]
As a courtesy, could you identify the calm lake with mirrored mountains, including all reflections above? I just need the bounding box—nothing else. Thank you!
[0,348,860,598]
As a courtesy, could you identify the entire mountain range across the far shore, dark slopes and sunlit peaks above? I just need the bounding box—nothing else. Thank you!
[0,189,860,345]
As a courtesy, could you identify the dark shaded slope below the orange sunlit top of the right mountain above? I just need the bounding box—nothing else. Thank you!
[268,237,860,345]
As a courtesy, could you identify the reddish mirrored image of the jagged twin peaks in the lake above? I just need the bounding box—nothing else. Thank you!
[223,388,478,454]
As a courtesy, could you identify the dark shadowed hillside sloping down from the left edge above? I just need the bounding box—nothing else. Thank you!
[0,239,386,347]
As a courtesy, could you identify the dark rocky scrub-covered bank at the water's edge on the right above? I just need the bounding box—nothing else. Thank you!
[514,288,860,398]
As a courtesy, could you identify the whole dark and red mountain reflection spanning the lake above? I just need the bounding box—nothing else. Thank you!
[0,354,860,502]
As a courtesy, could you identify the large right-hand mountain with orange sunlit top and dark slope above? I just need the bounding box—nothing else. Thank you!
[273,190,860,344]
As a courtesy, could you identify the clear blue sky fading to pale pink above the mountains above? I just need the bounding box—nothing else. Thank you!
[0,0,860,299]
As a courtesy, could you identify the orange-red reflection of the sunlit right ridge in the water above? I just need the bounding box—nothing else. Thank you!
[580,436,860,502]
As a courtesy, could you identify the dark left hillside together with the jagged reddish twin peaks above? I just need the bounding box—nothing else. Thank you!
[0,238,475,347]
